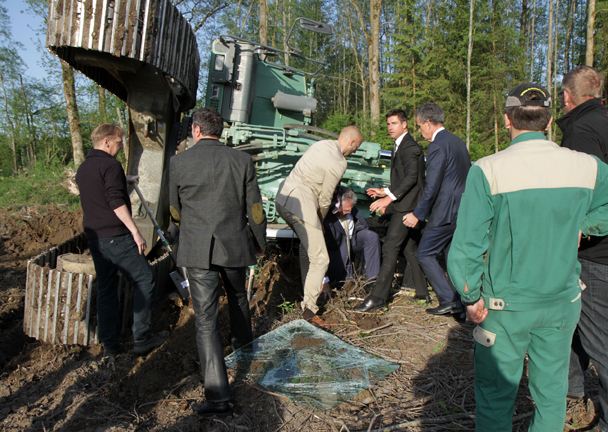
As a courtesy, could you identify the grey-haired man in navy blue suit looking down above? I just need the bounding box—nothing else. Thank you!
[403,103,471,315]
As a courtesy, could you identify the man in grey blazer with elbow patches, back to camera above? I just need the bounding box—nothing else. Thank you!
[170,108,266,417]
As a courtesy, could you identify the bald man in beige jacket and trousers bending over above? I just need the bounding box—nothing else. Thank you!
[276,126,363,325]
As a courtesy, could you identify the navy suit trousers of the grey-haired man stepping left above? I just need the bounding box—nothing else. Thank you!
[416,222,458,304]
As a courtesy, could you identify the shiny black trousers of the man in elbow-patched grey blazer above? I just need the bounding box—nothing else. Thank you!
[187,266,253,402]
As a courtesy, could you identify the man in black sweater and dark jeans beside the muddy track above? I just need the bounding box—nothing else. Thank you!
[76,124,165,360]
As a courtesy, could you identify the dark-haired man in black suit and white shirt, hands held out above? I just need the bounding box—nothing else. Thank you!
[354,109,428,312]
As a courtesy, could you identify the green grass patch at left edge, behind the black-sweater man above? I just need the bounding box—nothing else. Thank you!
[0,165,80,210]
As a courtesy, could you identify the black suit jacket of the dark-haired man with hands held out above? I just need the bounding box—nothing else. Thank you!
[386,133,424,214]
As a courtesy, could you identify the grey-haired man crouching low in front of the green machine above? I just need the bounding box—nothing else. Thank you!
[322,186,380,295]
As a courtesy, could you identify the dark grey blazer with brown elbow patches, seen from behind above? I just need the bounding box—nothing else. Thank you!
[169,139,266,269]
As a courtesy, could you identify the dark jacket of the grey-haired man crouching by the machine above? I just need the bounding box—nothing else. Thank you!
[323,207,369,279]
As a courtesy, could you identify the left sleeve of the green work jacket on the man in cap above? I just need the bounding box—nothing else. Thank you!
[448,165,494,303]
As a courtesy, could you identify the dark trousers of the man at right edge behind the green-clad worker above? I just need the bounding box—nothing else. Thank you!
[568,258,608,432]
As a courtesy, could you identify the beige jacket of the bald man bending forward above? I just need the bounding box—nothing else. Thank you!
[276,140,346,229]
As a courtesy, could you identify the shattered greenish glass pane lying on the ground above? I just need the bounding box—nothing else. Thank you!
[226,320,399,411]
